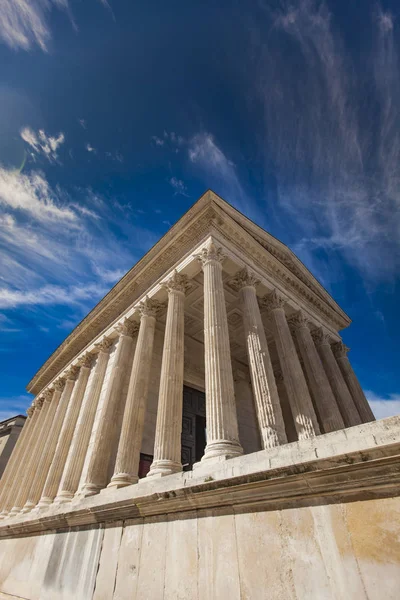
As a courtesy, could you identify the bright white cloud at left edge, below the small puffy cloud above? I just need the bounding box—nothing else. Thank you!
[0,167,76,223]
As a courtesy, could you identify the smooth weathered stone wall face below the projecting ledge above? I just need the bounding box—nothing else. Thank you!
[0,498,400,600]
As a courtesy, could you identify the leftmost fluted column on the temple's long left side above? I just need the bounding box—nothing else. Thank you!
[0,401,36,518]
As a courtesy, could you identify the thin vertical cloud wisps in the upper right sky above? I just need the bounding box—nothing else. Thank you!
[254,0,400,279]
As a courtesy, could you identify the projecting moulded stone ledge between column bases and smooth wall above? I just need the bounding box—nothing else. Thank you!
[0,416,400,538]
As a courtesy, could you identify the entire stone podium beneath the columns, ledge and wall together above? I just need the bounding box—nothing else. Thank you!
[0,418,400,600]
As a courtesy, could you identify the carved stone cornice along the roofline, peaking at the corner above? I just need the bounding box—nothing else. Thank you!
[27,190,350,394]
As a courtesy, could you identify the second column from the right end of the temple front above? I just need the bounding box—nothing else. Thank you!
[312,327,361,427]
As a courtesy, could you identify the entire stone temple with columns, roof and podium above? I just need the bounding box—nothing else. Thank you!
[0,191,400,600]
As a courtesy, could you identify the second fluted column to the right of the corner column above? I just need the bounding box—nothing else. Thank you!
[262,290,320,440]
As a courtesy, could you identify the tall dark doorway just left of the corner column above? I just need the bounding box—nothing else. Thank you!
[181,386,207,471]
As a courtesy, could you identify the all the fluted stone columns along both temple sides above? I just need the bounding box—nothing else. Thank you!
[0,244,374,516]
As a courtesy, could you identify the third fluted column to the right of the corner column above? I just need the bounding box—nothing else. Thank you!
[289,310,344,433]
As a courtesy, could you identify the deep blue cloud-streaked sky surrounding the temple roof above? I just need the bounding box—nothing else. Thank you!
[0,0,400,418]
